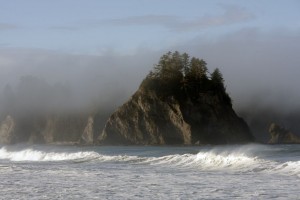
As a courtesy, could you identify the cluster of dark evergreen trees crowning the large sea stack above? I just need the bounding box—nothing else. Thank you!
[142,51,231,103]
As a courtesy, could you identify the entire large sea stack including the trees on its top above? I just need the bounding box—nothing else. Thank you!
[98,52,254,145]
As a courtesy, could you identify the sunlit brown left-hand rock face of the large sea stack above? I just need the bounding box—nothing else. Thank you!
[98,90,191,145]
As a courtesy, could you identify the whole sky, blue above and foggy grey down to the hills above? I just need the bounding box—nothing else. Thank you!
[0,0,300,110]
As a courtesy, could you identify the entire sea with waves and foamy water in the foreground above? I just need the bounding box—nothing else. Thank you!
[0,144,300,200]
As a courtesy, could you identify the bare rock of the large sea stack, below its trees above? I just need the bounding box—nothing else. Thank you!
[98,85,254,145]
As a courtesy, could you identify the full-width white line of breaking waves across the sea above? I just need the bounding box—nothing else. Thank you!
[0,147,300,177]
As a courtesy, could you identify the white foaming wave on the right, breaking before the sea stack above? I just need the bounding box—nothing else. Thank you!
[141,151,300,177]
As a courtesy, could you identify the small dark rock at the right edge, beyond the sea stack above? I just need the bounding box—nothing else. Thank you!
[268,123,300,144]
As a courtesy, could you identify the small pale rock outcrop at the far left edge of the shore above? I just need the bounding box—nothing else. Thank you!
[0,115,15,144]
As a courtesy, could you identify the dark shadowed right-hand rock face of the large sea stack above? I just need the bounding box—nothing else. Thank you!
[180,92,254,144]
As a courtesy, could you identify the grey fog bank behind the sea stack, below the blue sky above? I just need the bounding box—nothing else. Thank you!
[0,28,300,141]
